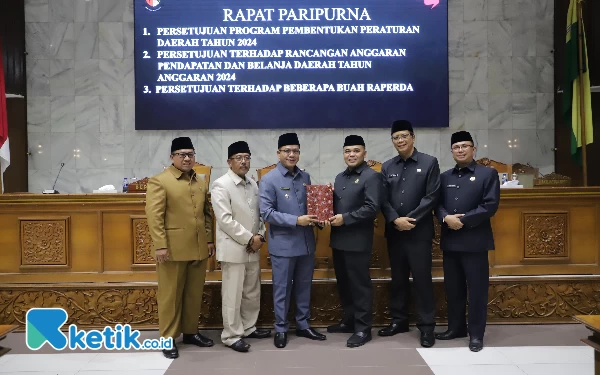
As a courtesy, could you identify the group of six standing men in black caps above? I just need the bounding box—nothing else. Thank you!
[146,120,500,358]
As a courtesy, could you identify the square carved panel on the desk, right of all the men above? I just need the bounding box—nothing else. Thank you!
[523,212,569,259]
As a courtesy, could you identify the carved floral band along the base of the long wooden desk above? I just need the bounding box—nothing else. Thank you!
[0,277,600,329]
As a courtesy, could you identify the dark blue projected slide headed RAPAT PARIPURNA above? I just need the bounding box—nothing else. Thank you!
[135,0,449,130]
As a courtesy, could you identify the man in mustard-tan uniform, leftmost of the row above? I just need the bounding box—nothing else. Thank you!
[146,137,215,359]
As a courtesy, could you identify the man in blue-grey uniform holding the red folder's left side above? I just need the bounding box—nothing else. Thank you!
[259,133,326,348]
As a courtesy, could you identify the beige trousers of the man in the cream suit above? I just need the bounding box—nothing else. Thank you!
[221,262,260,346]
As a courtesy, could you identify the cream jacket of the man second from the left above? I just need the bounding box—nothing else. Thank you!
[211,169,266,263]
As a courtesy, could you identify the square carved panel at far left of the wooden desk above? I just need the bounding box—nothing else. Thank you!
[19,217,69,268]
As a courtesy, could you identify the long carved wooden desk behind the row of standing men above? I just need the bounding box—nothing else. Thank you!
[0,187,600,329]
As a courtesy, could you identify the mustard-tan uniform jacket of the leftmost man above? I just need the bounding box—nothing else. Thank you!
[146,165,214,261]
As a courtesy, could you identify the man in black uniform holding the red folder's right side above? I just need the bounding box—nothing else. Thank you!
[327,135,383,348]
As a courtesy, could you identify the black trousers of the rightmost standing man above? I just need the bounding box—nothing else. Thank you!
[444,251,490,339]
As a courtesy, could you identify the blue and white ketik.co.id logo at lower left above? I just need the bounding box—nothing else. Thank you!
[25,308,173,350]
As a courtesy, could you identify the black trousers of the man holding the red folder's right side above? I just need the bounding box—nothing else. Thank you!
[333,249,373,332]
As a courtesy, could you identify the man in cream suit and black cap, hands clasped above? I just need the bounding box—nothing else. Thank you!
[211,141,271,352]
